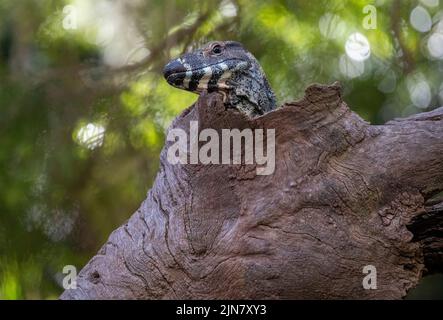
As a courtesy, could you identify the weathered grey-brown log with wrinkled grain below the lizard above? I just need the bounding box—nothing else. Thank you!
[61,84,443,299]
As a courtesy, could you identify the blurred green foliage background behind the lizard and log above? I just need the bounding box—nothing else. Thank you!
[0,0,443,299]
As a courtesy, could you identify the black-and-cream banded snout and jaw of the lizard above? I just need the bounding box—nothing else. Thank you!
[163,58,248,93]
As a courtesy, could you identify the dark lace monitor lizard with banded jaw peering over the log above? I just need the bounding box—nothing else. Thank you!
[163,41,276,117]
